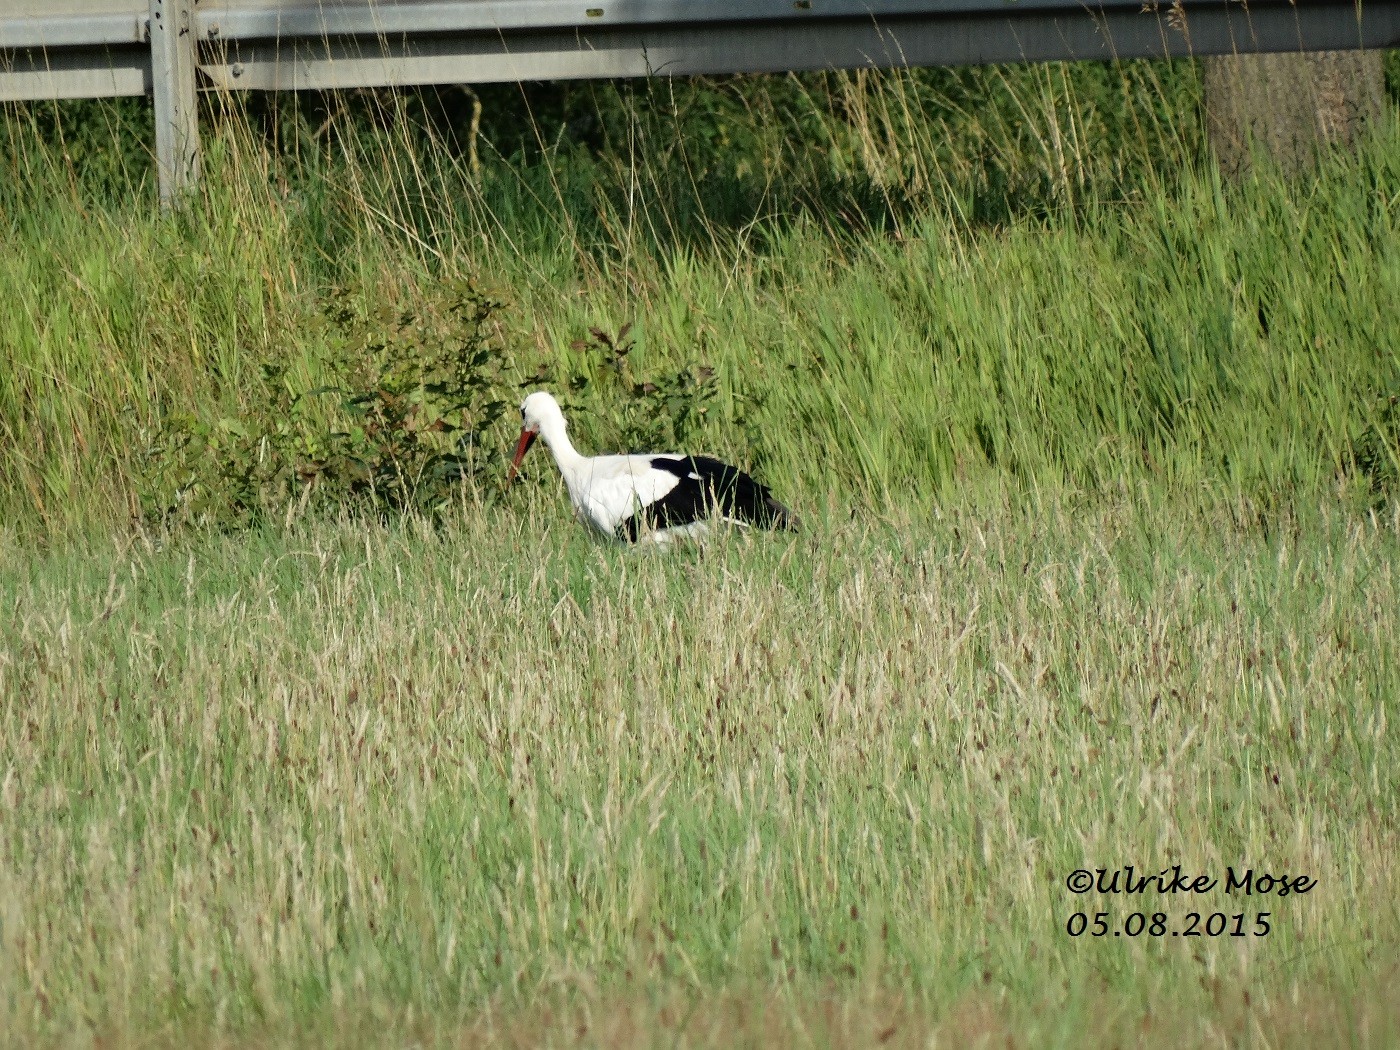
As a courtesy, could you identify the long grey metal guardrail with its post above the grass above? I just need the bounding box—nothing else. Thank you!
[0,0,1400,199]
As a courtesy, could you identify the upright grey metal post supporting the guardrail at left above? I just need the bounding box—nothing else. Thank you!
[150,0,199,207]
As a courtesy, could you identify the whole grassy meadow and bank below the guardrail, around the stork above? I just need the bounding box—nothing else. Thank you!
[0,63,1400,1047]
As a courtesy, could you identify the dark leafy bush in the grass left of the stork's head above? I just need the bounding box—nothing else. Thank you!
[140,284,508,525]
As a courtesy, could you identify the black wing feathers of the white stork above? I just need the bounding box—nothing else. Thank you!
[619,456,797,542]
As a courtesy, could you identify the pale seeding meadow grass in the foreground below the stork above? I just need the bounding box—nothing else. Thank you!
[0,493,1400,1044]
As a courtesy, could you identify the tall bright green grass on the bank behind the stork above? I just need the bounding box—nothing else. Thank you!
[0,64,1400,543]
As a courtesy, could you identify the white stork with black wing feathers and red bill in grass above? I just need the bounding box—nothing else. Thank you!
[505,391,798,545]
